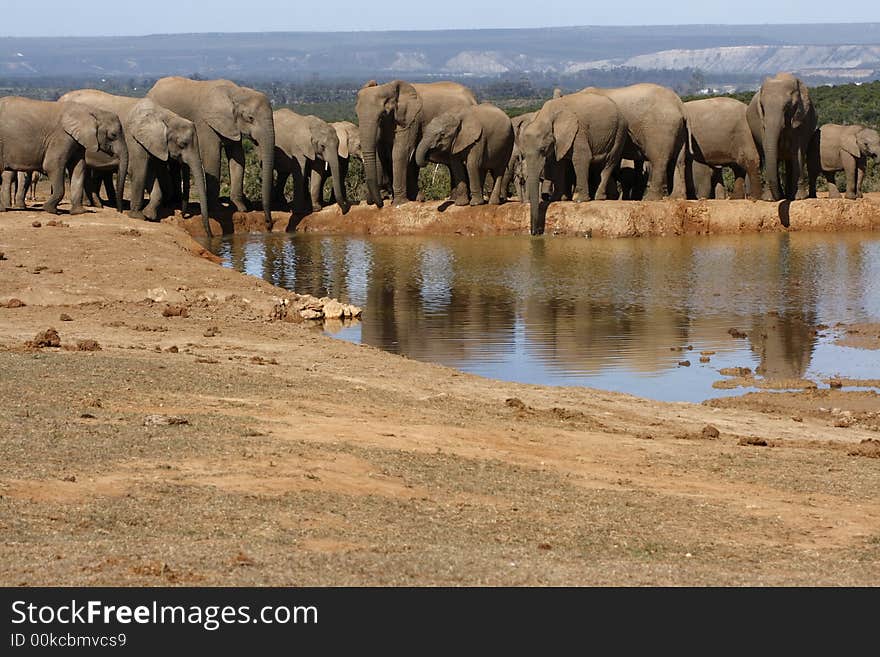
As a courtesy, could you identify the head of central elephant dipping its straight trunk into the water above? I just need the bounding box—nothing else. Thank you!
[520,109,580,235]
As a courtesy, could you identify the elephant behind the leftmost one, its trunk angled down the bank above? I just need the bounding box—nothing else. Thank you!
[61,89,211,237]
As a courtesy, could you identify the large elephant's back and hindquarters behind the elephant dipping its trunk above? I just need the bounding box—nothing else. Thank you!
[583,83,687,201]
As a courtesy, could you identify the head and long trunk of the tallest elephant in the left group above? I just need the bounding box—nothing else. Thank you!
[203,83,275,227]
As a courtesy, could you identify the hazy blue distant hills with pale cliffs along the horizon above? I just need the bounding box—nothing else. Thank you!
[0,23,880,82]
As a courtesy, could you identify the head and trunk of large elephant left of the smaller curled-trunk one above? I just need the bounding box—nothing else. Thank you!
[355,80,422,208]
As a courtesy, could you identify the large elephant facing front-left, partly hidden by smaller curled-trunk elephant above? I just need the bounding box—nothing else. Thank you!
[355,80,477,208]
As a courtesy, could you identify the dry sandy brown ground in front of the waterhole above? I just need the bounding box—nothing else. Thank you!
[0,210,880,585]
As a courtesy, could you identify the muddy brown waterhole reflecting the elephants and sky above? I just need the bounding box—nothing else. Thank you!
[214,233,880,401]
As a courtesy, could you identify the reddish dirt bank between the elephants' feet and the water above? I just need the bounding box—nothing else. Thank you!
[168,194,880,237]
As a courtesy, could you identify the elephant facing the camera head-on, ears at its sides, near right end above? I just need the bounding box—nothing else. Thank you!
[746,73,817,201]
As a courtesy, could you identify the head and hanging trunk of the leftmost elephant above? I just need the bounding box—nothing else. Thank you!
[61,102,128,212]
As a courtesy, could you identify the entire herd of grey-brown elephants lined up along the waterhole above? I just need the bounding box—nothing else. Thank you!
[0,73,880,235]
